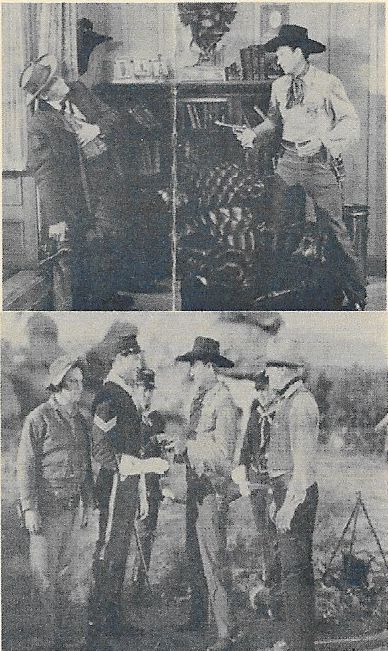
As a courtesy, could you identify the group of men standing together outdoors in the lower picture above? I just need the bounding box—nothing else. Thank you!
[17,328,318,651]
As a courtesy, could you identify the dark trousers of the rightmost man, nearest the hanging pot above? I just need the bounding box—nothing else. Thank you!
[272,479,318,651]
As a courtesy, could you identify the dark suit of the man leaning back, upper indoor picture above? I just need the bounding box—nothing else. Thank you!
[28,81,128,309]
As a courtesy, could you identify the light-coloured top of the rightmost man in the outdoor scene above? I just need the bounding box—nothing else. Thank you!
[266,380,319,498]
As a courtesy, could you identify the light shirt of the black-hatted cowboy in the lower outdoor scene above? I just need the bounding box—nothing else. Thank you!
[187,381,241,478]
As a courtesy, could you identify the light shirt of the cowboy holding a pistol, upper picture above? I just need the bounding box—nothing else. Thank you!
[255,65,360,158]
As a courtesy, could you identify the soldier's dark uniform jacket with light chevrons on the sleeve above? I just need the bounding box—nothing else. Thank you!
[92,381,143,508]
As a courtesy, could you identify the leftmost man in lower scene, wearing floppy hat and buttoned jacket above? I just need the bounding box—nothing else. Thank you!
[16,357,94,651]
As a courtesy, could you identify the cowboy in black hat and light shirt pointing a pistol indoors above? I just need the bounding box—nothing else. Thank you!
[236,25,366,306]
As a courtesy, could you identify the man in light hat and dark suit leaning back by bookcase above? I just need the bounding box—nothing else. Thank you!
[20,54,128,309]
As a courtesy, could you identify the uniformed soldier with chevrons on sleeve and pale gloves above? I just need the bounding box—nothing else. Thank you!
[89,334,168,649]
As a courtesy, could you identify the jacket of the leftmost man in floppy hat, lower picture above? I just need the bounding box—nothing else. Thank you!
[17,397,93,511]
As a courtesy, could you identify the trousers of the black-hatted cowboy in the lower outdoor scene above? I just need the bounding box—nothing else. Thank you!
[186,469,231,638]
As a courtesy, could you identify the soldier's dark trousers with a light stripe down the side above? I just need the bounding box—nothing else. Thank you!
[91,475,139,620]
